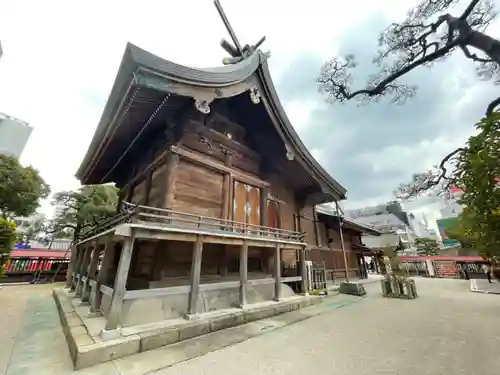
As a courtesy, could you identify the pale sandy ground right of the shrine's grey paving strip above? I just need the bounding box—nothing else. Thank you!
[150,279,500,375]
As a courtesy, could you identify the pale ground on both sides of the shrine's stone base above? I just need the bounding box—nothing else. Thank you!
[0,279,500,375]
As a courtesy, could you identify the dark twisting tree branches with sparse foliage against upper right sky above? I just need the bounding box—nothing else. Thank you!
[317,0,500,198]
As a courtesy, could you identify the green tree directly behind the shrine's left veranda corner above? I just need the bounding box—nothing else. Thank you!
[47,185,118,244]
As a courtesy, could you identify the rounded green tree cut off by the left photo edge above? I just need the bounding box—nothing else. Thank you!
[0,155,50,219]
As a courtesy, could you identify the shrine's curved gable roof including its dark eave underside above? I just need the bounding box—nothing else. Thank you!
[77,45,345,204]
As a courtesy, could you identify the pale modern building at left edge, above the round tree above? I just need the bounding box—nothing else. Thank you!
[0,112,33,159]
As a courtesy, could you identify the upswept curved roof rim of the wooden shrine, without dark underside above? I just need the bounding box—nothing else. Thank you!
[76,43,346,200]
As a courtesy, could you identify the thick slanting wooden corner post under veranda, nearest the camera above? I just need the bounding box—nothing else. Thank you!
[104,233,135,331]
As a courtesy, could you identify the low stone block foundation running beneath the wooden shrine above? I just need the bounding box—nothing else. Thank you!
[53,289,322,369]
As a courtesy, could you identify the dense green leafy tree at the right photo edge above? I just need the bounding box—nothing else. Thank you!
[399,112,500,258]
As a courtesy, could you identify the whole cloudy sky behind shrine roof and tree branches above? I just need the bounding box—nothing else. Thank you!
[0,0,498,229]
